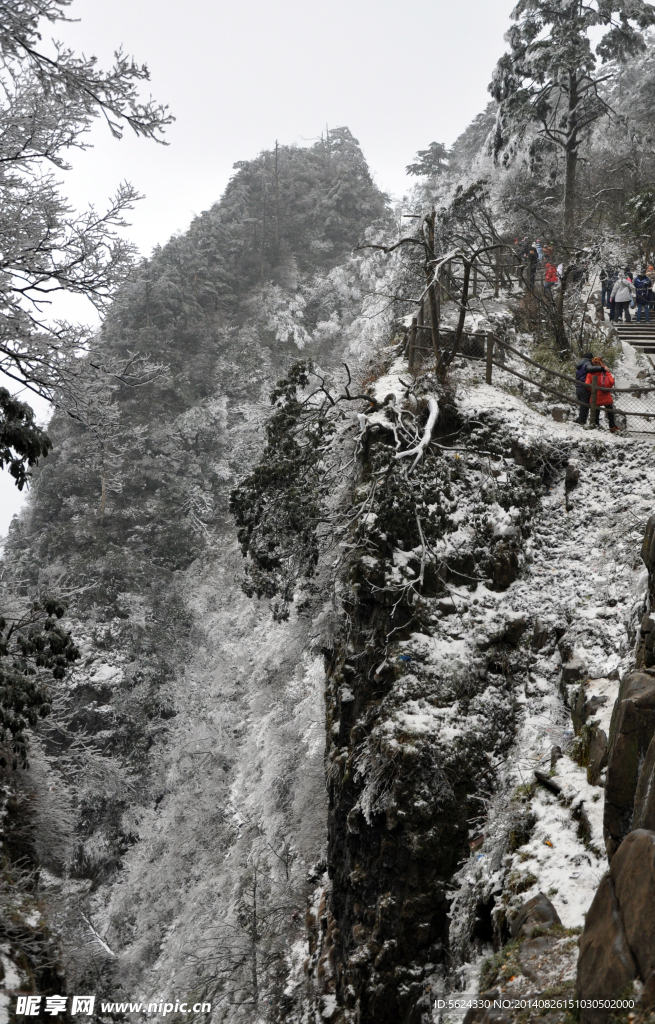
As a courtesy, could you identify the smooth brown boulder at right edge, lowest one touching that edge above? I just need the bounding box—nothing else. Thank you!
[610,828,655,981]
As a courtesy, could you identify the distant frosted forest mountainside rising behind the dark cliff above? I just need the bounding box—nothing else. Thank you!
[3,128,388,1019]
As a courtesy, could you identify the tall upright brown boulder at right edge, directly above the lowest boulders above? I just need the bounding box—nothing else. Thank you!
[603,672,655,860]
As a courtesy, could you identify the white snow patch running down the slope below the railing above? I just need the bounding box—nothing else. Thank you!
[440,358,655,1007]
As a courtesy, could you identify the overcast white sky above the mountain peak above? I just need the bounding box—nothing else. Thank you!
[0,0,515,535]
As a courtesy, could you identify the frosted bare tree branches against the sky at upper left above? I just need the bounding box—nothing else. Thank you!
[0,0,172,404]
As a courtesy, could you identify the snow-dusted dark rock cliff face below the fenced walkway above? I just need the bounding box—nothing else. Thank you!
[313,354,655,1022]
